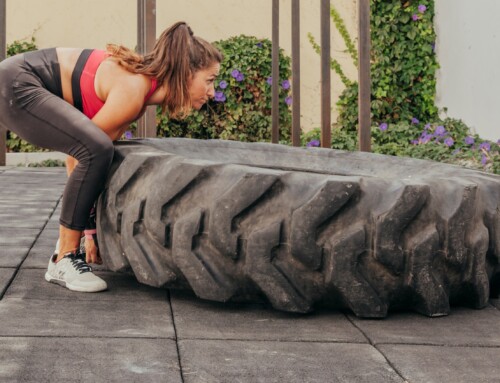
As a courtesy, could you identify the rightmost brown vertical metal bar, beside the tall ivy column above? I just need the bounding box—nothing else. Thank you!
[358,0,371,152]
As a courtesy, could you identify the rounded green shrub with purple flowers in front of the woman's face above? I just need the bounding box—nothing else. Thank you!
[157,35,291,142]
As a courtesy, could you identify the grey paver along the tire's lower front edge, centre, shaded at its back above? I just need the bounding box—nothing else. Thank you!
[171,293,368,343]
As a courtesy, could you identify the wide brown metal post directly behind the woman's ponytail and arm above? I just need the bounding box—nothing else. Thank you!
[137,0,156,137]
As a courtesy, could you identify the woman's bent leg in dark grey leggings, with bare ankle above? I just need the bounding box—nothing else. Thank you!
[0,72,113,259]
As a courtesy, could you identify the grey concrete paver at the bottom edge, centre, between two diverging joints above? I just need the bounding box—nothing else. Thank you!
[179,340,404,383]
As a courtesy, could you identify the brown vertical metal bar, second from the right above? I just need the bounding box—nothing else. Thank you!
[320,0,332,148]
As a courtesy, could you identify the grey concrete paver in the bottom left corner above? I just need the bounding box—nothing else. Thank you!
[0,337,182,383]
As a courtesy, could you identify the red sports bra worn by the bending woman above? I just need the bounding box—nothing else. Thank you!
[80,49,158,118]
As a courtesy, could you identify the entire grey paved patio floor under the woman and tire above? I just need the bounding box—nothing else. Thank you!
[0,167,500,383]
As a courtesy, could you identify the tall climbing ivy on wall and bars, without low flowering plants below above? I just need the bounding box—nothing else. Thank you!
[309,0,439,130]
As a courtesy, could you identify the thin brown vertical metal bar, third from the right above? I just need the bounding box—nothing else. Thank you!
[292,0,300,146]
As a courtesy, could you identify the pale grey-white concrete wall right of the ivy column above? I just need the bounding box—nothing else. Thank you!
[435,0,500,141]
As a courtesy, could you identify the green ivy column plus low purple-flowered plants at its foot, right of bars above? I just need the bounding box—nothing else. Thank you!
[302,0,500,174]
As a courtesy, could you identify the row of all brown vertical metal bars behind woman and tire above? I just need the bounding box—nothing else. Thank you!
[0,0,371,166]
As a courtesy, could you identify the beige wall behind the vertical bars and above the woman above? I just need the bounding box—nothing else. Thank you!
[7,0,357,130]
